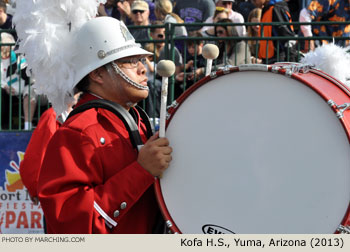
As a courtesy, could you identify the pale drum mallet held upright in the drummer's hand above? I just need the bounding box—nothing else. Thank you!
[157,60,175,137]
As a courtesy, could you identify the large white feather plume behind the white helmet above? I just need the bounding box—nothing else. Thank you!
[13,0,106,115]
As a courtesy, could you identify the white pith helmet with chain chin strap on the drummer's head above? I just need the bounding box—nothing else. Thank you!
[73,17,152,86]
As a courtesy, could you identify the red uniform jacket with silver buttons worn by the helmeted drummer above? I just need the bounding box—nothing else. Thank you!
[38,94,159,233]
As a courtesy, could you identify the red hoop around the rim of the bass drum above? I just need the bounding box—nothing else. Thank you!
[154,63,350,234]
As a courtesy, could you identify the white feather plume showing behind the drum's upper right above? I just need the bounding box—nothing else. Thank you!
[300,43,350,86]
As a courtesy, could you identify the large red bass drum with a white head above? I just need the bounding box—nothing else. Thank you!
[156,64,350,234]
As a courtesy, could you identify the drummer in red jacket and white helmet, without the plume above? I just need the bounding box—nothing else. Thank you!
[38,17,172,233]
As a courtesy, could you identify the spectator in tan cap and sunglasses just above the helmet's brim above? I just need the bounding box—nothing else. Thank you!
[130,0,151,41]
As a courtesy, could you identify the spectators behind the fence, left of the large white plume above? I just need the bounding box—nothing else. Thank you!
[0,0,44,130]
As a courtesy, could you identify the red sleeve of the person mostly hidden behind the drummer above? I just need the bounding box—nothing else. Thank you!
[19,108,61,197]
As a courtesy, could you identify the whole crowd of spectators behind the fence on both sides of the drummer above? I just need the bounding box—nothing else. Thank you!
[0,0,350,128]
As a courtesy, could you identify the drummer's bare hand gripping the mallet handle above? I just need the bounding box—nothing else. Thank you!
[137,132,173,176]
